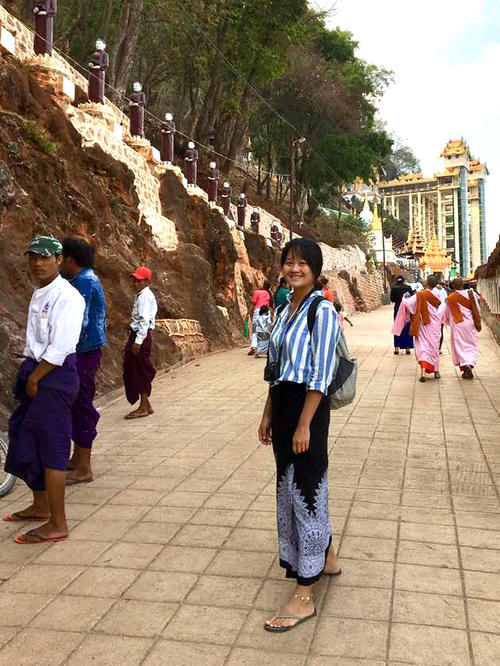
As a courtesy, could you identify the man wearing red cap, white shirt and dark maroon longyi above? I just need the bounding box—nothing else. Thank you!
[123,266,158,419]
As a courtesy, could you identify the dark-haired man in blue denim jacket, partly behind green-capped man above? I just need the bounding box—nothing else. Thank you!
[61,238,106,486]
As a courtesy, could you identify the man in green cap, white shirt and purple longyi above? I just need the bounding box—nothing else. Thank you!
[4,236,85,544]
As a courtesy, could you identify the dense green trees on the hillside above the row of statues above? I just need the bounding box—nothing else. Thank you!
[8,0,392,223]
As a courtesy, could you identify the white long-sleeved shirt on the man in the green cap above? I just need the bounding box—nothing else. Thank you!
[24,275,85,365]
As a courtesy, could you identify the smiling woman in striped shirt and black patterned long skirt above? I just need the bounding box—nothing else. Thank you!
[259,238,341,633]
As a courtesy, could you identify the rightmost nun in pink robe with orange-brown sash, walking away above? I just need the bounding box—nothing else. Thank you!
[443,278,481,379]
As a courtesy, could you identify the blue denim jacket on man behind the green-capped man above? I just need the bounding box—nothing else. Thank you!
[70,268,106,354]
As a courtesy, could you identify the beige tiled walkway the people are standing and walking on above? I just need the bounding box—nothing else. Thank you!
[0,308,500,666]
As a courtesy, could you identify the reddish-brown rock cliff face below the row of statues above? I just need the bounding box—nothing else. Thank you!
[0,56,272,425]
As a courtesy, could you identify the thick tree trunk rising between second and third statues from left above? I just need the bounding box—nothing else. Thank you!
[110,0,144,102]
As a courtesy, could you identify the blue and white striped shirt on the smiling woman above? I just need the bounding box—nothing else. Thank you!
[269,291,341,395]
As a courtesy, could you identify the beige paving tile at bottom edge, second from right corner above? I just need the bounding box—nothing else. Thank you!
[390,624,470,666]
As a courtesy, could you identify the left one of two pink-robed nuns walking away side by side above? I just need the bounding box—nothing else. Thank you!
[393,276,442,382]
